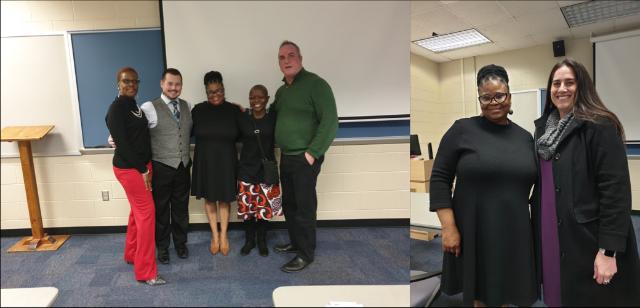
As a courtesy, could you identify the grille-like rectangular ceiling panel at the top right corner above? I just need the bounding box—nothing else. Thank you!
[560,1,640,28]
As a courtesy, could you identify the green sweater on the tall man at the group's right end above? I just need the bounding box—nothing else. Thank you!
[272,68,338,158]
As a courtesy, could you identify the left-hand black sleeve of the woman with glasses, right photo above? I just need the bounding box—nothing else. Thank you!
[429,121,462,212]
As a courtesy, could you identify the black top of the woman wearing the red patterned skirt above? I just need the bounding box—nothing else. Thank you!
[238,111,276,184]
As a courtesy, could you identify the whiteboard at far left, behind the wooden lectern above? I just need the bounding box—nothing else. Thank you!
[0,34,80,157]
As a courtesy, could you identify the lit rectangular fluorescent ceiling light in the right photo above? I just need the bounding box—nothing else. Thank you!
[413,29,491,53]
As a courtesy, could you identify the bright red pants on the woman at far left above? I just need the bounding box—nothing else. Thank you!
[113,163,158,280]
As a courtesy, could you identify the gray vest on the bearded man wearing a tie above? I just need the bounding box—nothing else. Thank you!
[149,97,193,168]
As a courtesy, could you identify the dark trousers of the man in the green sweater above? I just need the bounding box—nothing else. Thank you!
[280,153,324,262]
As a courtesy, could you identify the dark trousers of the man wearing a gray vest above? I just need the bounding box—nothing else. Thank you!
[151,161,191,249]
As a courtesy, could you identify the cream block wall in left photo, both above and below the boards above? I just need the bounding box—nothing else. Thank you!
[0,1,409,229]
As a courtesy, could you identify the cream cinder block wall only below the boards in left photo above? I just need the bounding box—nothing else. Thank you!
[0,143,409,229]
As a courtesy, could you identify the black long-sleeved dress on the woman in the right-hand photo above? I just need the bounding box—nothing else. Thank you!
[430,116,537,306]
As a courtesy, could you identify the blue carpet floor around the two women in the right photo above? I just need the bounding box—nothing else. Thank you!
[410,215,640,307]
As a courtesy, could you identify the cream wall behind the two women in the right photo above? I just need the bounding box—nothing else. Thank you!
[411,38,640,210]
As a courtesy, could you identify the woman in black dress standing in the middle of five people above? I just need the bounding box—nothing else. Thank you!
[191,71,241,256]
